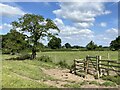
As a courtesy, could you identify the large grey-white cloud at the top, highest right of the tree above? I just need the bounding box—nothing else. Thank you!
[53,2,110,23]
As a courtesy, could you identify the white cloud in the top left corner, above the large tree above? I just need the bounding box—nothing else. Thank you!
[0,3,25,17]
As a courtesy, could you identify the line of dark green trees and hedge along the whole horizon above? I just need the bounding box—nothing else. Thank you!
[1,29,120,54]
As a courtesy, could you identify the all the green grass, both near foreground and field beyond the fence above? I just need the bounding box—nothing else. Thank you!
[2,51,118,88]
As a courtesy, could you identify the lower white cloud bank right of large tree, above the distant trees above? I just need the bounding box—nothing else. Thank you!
[54,18,94,45]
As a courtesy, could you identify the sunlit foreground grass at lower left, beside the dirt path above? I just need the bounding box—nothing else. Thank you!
[2,60,55,88]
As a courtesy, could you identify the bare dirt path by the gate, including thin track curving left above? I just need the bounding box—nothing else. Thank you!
[12,65,117,88]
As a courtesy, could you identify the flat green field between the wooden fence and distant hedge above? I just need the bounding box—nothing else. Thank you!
[37,51,118,64]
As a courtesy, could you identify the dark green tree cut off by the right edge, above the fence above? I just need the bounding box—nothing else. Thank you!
[110,36,120,50]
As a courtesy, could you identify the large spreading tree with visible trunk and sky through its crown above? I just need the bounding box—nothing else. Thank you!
[12,14,59,59]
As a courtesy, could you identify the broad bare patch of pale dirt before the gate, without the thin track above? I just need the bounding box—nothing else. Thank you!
[41,68,113,88]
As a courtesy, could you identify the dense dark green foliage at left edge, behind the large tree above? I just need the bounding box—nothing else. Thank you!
[2,30,29,54]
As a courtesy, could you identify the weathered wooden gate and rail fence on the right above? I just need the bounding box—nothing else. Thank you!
[73,55,120,78]
